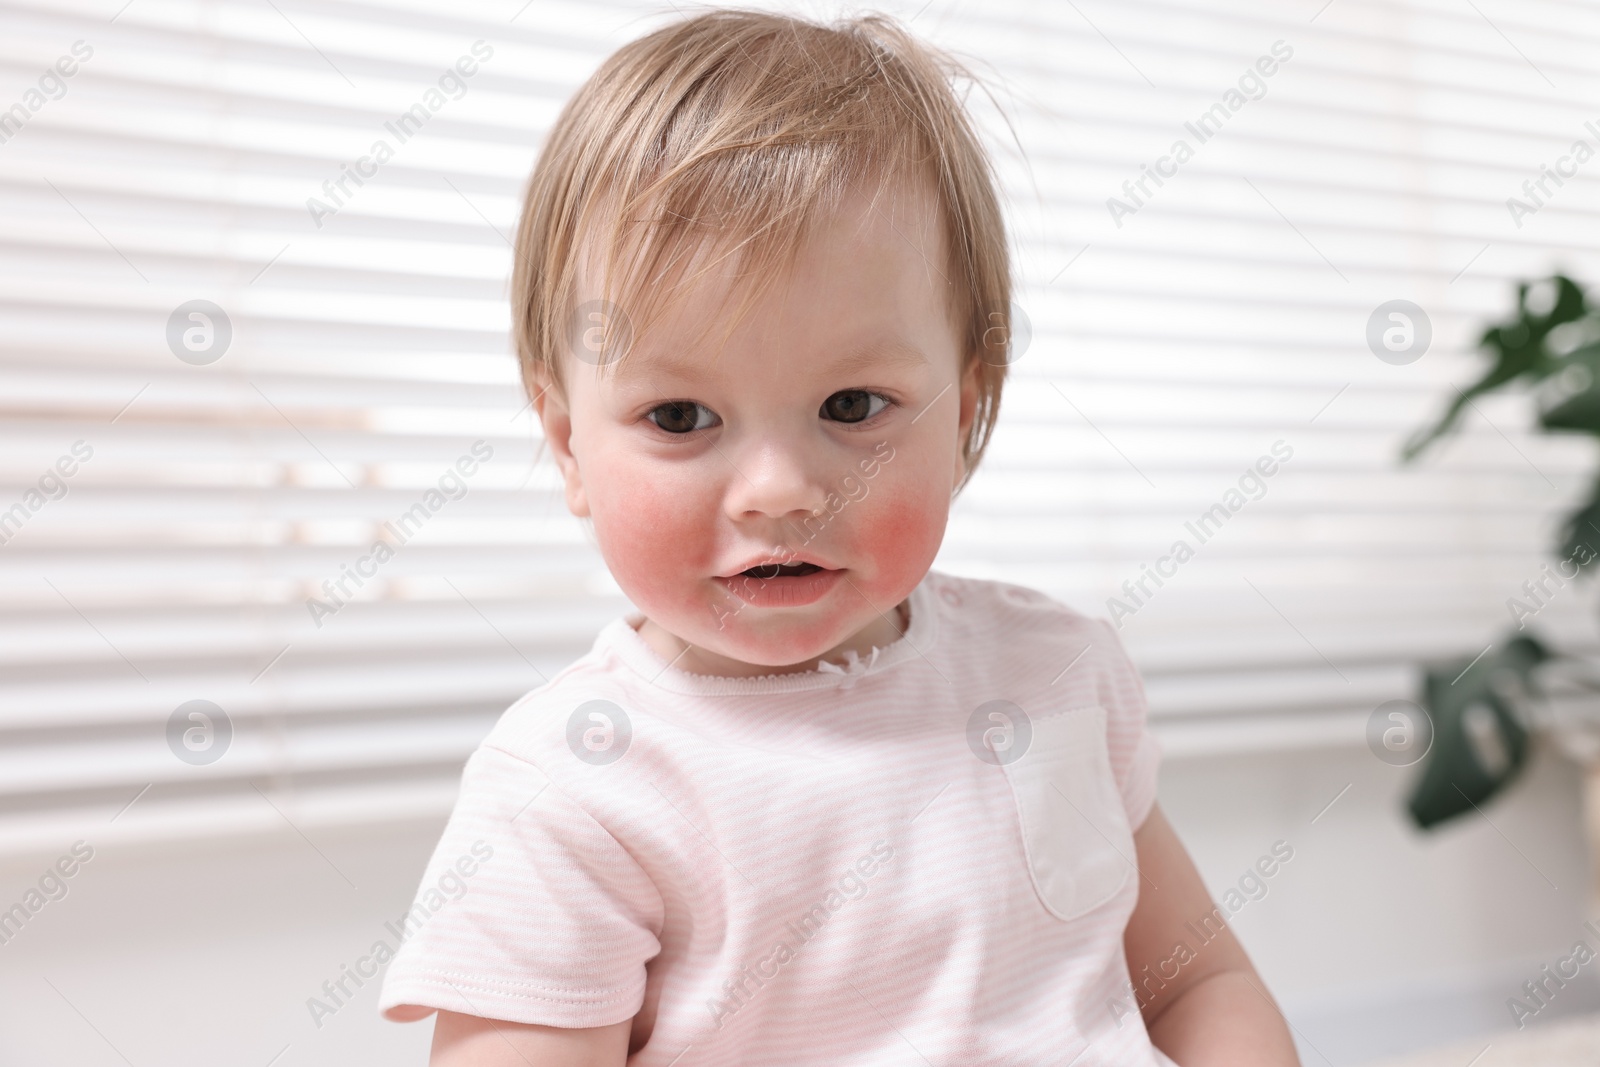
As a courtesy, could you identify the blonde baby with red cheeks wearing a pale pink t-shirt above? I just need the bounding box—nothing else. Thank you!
[381,10,1298,1067]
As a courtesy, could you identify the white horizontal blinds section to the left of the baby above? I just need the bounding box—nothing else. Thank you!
[0,0,640,849]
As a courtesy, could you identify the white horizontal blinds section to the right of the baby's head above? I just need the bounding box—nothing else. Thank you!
[944,0,1600,752]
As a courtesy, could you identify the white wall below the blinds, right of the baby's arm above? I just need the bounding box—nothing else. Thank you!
[1160,747,1600,1067]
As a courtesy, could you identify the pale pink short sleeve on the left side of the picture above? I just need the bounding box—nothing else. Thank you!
[374,745,662,1027]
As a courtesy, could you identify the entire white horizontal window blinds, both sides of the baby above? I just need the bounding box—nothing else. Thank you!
[0,0,1600,848]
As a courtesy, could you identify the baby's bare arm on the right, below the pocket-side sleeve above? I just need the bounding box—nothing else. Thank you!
[1123,808,1299,1067]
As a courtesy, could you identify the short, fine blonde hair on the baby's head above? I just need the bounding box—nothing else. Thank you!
[512,8,1011,485]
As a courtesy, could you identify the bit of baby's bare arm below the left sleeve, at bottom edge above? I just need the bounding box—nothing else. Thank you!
[427,1011,634,1067]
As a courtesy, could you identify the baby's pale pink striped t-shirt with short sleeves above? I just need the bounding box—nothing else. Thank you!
[379,573,1171,1067]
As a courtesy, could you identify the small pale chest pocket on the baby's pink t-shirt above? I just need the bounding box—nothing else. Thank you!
[1005,707,1136,921]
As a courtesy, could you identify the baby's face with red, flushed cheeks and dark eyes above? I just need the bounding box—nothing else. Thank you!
[539,179,976,675]
